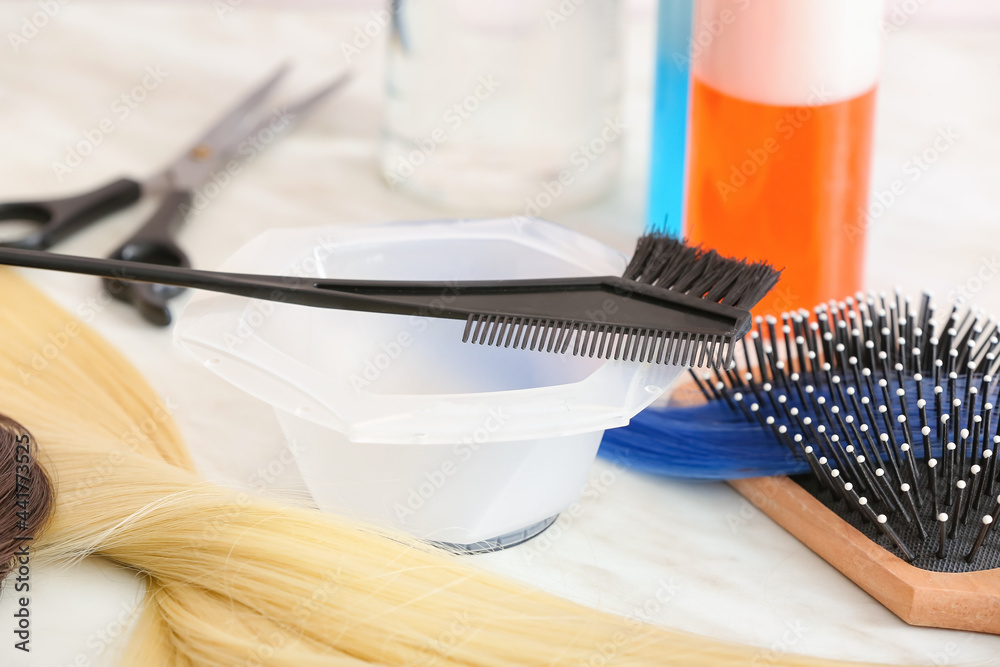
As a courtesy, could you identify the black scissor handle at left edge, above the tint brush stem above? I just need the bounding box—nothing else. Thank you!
[0,178,142,250]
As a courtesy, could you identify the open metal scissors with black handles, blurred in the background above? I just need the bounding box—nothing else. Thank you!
[0,65,350,326]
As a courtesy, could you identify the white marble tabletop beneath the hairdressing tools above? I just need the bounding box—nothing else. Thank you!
[0,1,1000,666]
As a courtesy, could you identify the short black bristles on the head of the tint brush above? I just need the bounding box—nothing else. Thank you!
[622,233,781,310]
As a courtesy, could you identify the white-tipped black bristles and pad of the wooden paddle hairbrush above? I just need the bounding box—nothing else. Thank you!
[699,293,1000,572]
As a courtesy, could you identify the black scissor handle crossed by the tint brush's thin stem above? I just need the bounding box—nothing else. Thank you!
[102,191,191,327]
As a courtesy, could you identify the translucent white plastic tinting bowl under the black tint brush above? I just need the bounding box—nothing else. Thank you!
[174,218,680,550]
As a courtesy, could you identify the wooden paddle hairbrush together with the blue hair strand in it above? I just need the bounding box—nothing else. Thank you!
[602,293,1000,634]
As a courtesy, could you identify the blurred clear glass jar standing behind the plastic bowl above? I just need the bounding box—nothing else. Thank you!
[379,0,624,216]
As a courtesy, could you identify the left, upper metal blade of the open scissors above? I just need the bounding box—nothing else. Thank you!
[157,64,288,191]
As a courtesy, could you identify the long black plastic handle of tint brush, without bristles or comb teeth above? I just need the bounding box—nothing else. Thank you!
[0,248,750,337]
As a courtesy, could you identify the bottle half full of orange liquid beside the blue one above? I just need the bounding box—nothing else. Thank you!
[686,0,881,315]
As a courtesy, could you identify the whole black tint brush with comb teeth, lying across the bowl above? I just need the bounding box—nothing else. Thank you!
[0,234,780,367]
